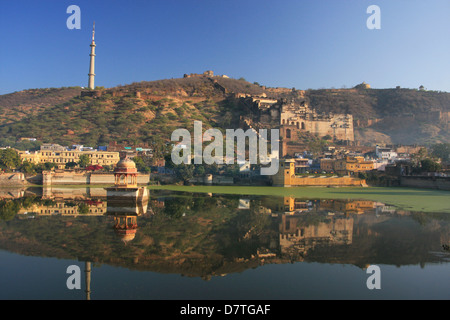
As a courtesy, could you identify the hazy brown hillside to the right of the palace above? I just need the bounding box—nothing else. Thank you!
[306,89,450,144]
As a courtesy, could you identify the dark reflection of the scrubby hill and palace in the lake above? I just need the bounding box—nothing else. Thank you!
[0,194,450,278]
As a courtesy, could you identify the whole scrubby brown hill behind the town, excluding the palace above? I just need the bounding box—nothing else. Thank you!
[0,74,450,146]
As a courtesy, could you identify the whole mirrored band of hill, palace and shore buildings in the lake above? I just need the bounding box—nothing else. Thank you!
[0,188,450,279]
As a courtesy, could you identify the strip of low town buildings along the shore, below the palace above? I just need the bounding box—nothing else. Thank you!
[0,121,449,190]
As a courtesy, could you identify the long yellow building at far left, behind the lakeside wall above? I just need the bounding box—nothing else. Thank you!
[18,150,120,169]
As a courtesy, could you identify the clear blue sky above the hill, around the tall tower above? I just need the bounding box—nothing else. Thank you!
[0,0,450,94]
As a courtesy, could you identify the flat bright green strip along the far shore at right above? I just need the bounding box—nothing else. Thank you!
[149,185,450,213]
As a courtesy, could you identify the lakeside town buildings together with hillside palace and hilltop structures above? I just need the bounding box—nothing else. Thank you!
[0,75,450,190]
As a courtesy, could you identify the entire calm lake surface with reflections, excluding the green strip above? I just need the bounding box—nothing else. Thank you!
[0,187,450,300]
